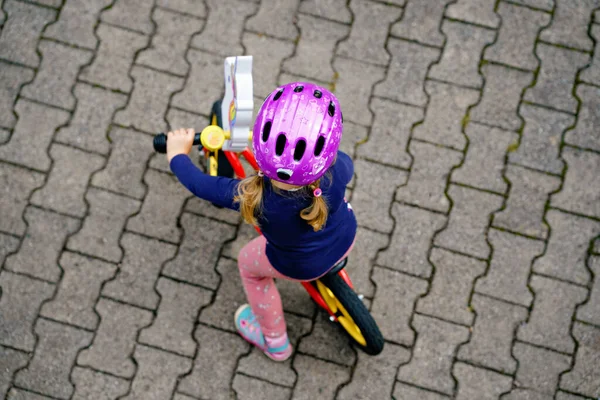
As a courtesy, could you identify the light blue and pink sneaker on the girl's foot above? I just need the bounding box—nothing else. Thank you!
[234,304,292,361]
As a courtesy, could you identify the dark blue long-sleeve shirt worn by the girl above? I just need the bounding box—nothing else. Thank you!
[170,152,357,280]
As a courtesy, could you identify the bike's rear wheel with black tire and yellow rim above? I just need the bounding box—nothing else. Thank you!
[316,274,384,355]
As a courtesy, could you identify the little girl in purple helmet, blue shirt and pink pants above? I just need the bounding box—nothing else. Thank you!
[167,82,356,361]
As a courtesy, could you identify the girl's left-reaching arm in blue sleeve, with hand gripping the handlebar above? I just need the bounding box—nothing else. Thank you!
[167,129,239,210]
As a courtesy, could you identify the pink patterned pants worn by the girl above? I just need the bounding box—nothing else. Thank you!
[238,235,354,337]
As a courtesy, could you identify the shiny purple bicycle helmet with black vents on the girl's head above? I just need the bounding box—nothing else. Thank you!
[252,82,343,186]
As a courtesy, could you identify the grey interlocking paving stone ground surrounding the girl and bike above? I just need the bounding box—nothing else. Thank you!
[0,0,600,400]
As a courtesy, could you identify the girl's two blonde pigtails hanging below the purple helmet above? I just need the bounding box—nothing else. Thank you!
[234,175,329,232]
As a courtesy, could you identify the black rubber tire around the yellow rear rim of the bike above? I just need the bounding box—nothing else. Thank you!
[320,274,384,356]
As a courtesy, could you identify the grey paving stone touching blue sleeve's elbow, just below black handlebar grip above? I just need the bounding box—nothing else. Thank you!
[127,170,190,242]
